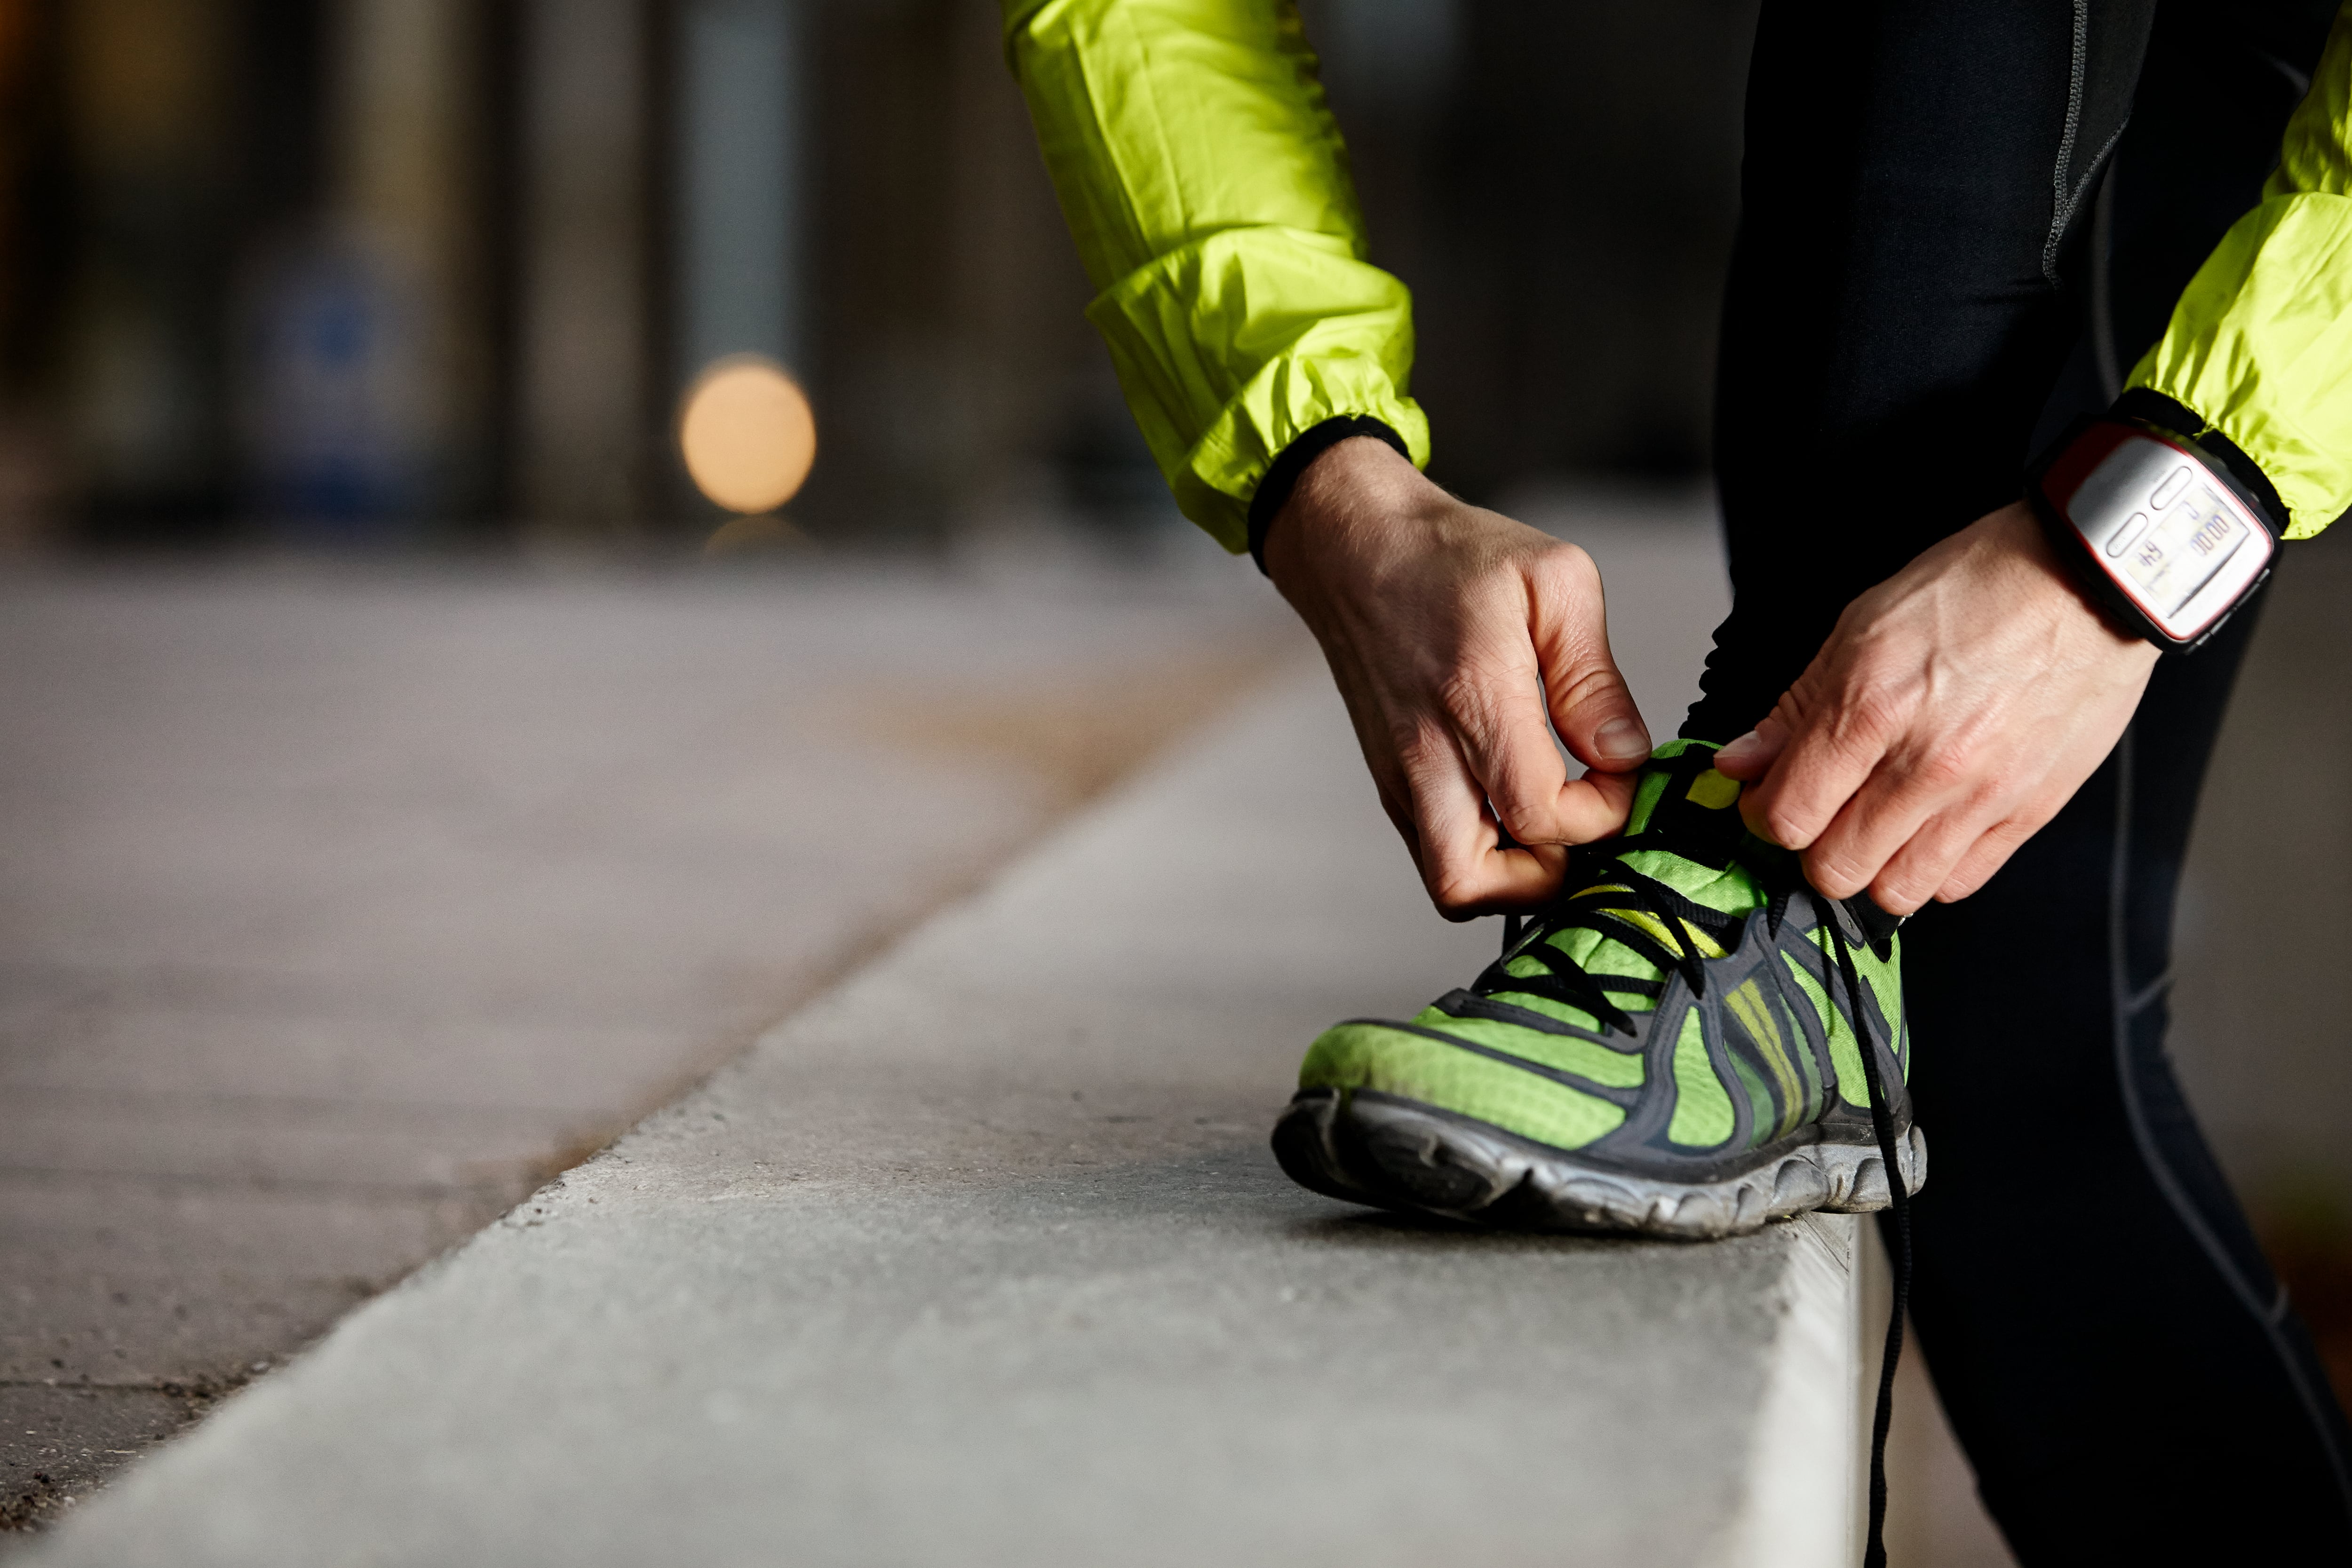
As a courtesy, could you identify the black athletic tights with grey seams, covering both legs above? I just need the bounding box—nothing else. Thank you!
[1684,0,2352,1566]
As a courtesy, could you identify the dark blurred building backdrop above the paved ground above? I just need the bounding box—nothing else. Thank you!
[0,0,1750,546]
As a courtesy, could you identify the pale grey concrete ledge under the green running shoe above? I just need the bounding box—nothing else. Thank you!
[28,668,1870,1568]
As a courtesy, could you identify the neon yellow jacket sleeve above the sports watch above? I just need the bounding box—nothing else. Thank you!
[2129,5,2352,539]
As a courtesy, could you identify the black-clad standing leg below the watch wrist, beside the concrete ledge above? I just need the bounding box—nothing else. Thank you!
[1905,566,2352,1563]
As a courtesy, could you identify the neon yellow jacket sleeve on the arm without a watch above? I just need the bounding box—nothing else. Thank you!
[1004,0,1430,553]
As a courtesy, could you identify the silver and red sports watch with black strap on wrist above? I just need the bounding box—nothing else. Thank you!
[2025,414,2279,654]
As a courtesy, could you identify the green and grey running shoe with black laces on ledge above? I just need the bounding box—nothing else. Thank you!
[1275,741,1926,1236]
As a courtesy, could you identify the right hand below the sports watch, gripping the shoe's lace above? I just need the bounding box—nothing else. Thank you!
[1715,501,2157,914]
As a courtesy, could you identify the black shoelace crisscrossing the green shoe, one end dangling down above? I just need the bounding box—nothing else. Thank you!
[1505,834,1912,1568]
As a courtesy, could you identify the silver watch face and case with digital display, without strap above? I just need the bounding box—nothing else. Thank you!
[2046,426,2272,642]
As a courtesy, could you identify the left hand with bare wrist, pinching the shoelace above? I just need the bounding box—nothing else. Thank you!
[1265,437,1649,919]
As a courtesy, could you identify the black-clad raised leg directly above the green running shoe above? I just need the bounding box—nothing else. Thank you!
[1684,0,2145,741]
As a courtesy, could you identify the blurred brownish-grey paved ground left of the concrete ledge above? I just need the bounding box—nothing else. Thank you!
[0,548,1301,1519]
